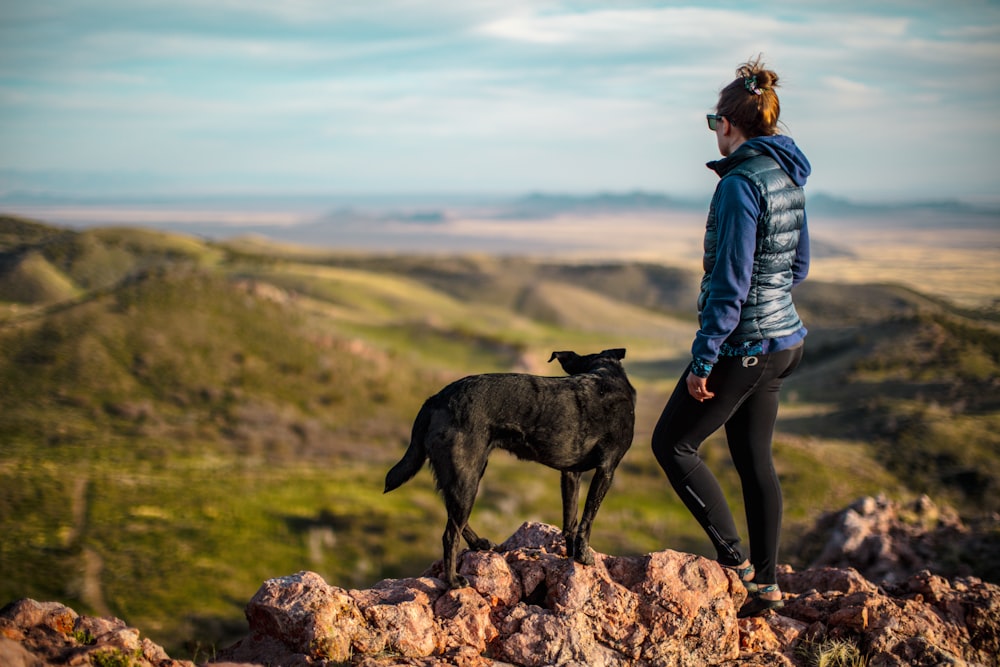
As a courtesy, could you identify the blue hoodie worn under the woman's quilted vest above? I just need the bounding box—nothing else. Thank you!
[691,135,812,374]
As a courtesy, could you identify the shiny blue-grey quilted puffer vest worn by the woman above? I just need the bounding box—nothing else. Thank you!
[698,147,806,344]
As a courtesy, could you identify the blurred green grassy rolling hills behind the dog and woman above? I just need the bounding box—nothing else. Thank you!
[0,218,1000,657]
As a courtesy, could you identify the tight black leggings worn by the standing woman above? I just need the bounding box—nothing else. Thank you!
[653,345,803,585]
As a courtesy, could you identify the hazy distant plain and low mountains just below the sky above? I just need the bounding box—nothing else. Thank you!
[0,190,1000,247]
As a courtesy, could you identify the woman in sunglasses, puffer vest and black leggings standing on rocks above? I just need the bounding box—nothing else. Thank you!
[653,58,810,618]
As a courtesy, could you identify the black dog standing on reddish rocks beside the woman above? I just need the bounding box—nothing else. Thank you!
[385,349,635,588]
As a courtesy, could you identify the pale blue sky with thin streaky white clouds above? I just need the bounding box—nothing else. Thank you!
[0,0,1000,203]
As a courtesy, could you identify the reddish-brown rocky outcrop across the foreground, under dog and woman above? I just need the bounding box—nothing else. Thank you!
[0,508,1000,667]
